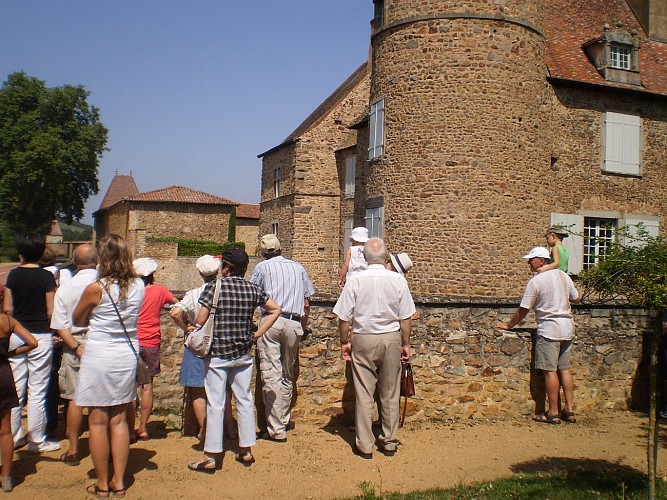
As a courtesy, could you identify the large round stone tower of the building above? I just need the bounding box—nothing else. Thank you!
[368,0,557,299]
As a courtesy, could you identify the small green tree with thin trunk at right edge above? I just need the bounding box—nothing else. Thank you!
[580,224,667,498]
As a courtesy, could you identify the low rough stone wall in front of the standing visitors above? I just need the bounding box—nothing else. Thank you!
[155,300,651,423]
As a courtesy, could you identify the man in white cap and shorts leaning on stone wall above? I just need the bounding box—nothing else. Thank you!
[496,247,580,424]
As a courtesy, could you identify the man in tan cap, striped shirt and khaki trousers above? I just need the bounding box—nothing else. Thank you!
[250,234,315,443]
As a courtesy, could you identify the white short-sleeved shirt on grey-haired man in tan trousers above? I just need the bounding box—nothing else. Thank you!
[333,264,416,334]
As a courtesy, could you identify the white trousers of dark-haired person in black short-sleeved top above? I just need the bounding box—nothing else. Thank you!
[9,333,53,444]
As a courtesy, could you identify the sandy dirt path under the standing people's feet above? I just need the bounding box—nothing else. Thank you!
[7,411,667,499]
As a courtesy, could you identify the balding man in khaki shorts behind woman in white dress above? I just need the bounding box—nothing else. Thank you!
[51,243,97,465]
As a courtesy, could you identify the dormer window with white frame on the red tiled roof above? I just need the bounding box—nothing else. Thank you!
[582,24,641,85]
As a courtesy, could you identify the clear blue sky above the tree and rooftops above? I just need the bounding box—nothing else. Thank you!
[0,0,373,223]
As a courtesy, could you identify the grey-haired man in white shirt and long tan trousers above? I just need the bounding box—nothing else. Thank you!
[333,238,415,459]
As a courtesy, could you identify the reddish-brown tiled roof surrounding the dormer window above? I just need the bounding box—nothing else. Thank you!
[545,0,667,95]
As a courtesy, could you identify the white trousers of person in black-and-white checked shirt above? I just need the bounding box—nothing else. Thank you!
[204,355,256,453]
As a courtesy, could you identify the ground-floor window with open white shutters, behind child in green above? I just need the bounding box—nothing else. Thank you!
[551,211,660,274]
